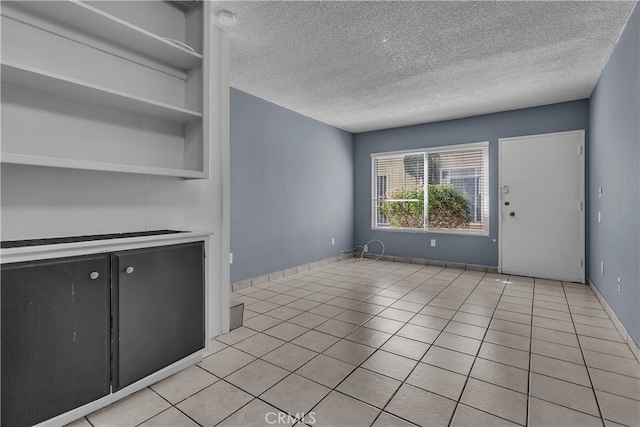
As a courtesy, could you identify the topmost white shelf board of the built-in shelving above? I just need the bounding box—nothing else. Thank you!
[15,0,202,70]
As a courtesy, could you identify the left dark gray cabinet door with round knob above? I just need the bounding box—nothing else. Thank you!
[1,255,111,426]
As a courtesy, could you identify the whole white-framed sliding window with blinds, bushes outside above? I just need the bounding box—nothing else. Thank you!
[371,142,489,234]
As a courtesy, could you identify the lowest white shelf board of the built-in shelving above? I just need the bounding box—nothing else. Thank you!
[0,153,207,179]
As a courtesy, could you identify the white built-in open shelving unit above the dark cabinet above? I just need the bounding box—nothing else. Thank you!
[1,0,209,179]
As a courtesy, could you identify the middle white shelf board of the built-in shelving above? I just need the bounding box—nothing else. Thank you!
[2,63,202,124]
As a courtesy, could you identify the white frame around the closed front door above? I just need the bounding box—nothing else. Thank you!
[497,129,587,283]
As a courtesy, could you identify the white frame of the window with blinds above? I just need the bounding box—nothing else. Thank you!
[371,141,491,236]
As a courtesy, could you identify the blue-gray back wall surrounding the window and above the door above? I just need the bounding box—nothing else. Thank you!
[354,100,589,267]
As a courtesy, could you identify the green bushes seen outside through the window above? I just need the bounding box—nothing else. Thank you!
[378,184,471,228]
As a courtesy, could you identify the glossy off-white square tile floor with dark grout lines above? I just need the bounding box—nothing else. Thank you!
[74,260,640,427]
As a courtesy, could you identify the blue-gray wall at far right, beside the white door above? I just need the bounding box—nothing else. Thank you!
[588,6,640,343]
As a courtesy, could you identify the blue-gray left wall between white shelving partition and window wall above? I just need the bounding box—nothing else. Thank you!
[230,88,353,283]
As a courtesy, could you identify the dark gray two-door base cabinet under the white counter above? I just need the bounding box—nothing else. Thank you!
[0,242,205,427]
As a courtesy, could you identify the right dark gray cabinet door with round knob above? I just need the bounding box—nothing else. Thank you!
[112,242,204,390]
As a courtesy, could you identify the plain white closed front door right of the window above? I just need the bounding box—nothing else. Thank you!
[498,130,584,283]
